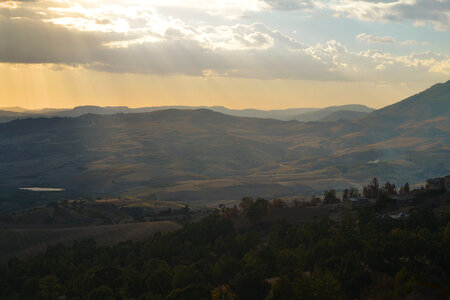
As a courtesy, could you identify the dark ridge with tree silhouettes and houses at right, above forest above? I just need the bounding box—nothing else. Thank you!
[224,175,450,219]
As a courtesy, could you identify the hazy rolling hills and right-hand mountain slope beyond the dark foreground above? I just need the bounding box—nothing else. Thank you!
[0,81,450,209]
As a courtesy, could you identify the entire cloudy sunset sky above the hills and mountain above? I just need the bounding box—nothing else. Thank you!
[0,0,450,109]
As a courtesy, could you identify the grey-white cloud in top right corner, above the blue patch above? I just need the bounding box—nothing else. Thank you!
[330,0,450,31]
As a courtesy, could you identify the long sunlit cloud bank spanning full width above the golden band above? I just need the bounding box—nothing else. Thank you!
[0,1,448,81]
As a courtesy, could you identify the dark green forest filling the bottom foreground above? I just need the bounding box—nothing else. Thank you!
[0,205,450,300]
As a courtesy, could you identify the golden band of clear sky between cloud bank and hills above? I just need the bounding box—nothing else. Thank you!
[0,64,432,109]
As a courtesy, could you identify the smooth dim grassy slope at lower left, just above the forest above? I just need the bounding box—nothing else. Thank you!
[0,221,181,263]
